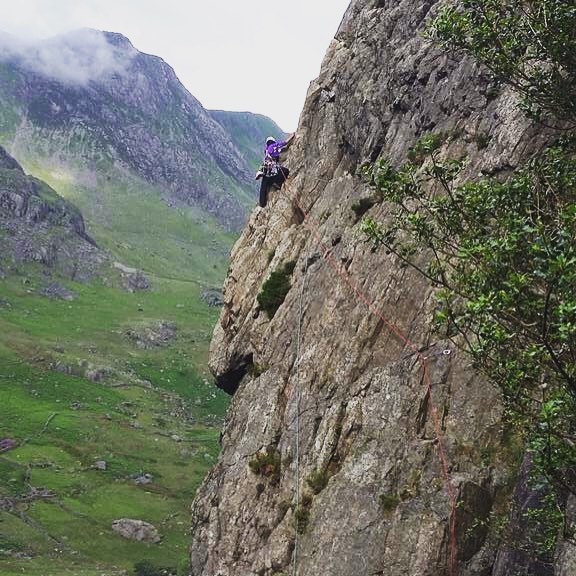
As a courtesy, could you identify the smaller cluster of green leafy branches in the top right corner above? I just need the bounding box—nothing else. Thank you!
[428,0,576,122]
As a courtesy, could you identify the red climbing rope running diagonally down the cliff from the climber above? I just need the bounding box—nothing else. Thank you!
[280,166,457,576]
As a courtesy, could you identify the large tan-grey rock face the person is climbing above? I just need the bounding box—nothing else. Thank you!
[191,0,575,576]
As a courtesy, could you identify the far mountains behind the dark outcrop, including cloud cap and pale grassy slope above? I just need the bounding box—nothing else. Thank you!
[0,30,286,286]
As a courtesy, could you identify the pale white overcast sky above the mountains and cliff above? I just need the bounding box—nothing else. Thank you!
[0,0,350,132]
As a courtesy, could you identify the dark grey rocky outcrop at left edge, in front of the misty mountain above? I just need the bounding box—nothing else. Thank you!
[0,147,106,281]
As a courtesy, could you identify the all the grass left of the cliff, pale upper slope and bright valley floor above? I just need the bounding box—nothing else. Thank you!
[0,115,241,576]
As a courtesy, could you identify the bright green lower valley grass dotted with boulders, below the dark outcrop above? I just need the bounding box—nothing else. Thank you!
[0,271,227,576]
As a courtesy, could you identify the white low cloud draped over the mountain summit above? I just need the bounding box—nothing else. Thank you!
[0,28,137,85]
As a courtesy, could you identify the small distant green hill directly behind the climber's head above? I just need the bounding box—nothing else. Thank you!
[210,110,288,169]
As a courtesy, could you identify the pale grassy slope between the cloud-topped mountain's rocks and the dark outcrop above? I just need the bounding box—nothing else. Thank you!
[19,157,234,286]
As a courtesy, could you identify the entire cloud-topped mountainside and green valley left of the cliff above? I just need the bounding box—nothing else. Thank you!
[0,31,284,576]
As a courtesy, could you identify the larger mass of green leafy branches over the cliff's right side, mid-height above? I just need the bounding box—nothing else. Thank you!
[361,140,576,489]
